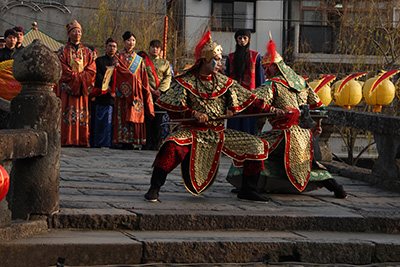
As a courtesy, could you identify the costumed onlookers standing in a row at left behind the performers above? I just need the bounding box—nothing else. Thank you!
[0,20,173,150]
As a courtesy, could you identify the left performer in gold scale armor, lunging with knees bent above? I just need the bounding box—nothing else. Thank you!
[145,31,282,202]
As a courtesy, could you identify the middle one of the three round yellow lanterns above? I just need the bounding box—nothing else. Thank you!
[332,79,362,109]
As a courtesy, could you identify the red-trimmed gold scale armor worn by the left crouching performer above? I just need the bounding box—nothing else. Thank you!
[156,70,272,195]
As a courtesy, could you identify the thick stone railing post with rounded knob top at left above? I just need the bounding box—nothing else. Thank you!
[10,40,62,219]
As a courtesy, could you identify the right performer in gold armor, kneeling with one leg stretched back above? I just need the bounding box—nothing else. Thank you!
[227,37,347,198]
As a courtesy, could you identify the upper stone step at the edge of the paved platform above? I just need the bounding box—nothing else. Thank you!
[49,207,400,234]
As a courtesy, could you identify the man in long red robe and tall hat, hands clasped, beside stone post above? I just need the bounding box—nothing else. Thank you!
[58,20,96,147]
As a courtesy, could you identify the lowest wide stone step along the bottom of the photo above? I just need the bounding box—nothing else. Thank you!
[0,229,400,267]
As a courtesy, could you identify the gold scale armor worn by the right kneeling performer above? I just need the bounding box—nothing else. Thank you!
[227,56,332,192]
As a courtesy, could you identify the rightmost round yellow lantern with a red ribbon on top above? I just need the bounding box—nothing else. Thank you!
[363,73,395,112]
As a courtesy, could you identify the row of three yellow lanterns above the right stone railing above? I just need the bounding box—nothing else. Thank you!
[309,70,400,112]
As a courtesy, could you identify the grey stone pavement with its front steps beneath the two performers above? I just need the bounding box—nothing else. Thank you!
[0,148,400,266]
